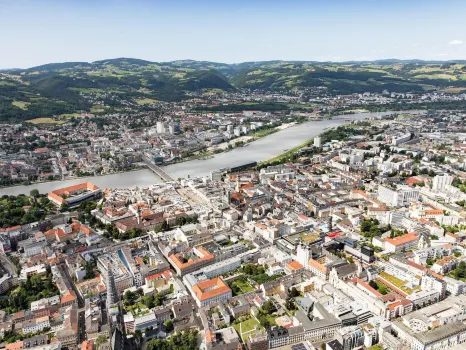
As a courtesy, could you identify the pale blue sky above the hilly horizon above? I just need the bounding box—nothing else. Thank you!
[0,0,466,69]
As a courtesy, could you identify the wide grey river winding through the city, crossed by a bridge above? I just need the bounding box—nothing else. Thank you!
[0,111,419,196]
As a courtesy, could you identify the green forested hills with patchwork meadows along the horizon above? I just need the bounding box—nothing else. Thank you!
[0,58,466,122]
